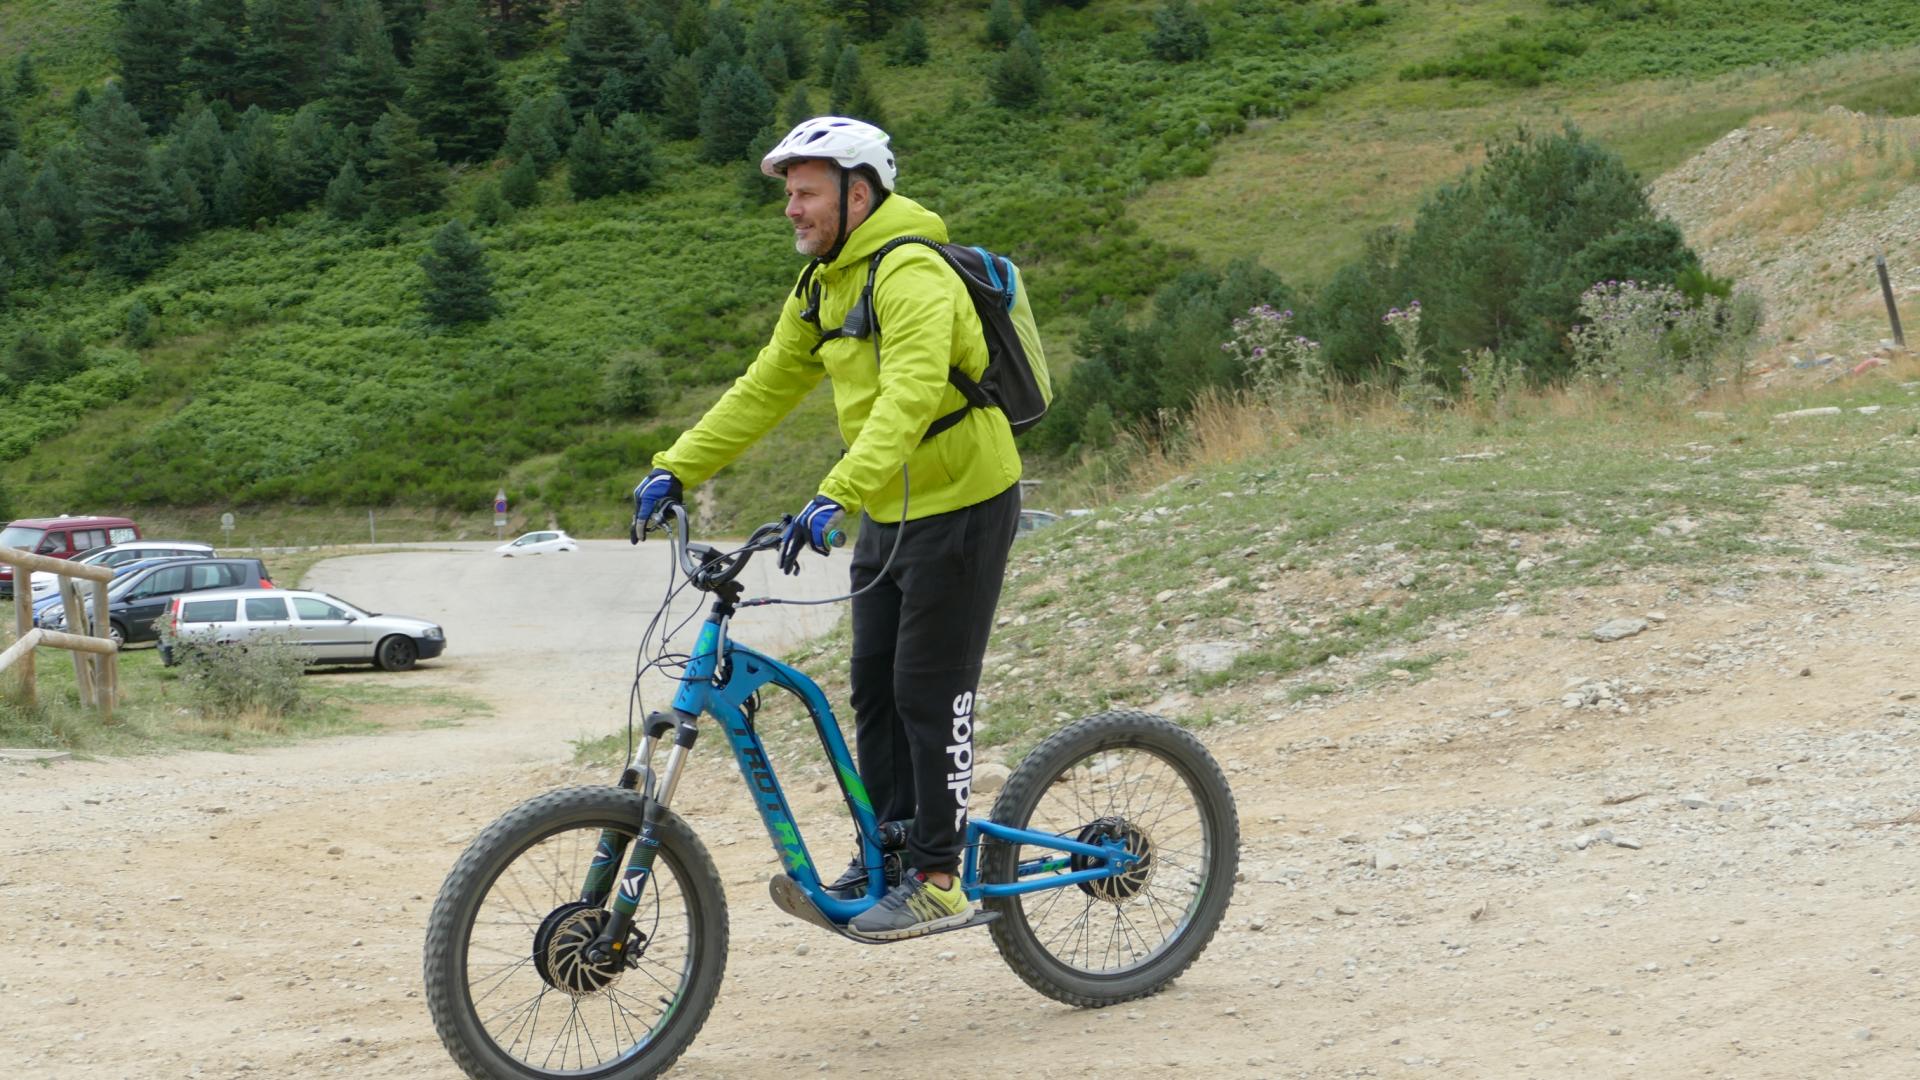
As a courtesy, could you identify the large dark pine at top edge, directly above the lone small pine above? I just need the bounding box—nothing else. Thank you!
[407,4,507,161]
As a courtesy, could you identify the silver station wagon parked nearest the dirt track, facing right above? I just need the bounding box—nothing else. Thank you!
[159,588,447,671]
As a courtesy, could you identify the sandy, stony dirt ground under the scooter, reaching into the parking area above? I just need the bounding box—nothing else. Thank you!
[0,546,1920,1080]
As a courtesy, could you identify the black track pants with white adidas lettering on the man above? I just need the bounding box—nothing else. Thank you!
[851,484,1020,872]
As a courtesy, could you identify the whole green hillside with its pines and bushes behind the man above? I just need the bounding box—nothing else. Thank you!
[0,0,1920,536]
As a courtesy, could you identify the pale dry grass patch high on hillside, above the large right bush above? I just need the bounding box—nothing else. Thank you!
[1129,38,1920,286]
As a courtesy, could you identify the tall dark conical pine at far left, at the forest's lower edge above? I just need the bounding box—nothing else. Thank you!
[79,83,184,275]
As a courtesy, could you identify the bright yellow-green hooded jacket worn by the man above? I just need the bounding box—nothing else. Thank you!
[653,194,1020,523]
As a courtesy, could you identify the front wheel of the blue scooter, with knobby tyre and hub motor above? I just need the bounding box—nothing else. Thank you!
[424,788,728,1080]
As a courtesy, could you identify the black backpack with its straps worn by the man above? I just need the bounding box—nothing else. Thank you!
[793,236,1054,442]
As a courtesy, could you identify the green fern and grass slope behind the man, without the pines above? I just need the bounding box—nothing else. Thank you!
[0,0,1920,540]
